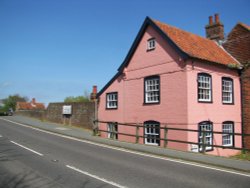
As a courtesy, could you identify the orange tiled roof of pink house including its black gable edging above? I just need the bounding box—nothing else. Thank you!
[97,17,240,97]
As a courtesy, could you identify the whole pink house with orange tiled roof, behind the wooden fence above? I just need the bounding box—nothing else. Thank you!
[98,17,241,156]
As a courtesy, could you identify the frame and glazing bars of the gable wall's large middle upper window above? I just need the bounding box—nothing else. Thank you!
[144,75,161,105]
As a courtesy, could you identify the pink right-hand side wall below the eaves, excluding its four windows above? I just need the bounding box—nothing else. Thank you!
[187,61,241,156]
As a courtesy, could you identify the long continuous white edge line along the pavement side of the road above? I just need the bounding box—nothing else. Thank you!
[0,118,250,177]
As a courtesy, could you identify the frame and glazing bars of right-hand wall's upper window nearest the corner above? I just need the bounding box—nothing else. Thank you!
[197,73,213,103]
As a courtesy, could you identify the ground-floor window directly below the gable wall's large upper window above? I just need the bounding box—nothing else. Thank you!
[144,121,160,146]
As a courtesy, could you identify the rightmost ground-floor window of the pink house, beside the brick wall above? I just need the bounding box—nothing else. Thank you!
[222,121,234,146]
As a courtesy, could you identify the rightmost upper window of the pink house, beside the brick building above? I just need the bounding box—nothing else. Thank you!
[222,77,233,104]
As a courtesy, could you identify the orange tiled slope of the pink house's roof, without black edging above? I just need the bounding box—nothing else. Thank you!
[153,20,239,66]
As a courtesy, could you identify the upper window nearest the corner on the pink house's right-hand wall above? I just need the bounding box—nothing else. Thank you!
[197,73,212,102]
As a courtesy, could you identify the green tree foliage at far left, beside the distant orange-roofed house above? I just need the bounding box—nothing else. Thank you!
[3,94,28,111]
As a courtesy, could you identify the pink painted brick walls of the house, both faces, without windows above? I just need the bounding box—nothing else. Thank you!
[98,27,241,156]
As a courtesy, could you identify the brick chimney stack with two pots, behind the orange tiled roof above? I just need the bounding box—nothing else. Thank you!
[205,14,224,42]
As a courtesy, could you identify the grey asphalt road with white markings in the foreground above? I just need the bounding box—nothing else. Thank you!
[0,120,250,188]
